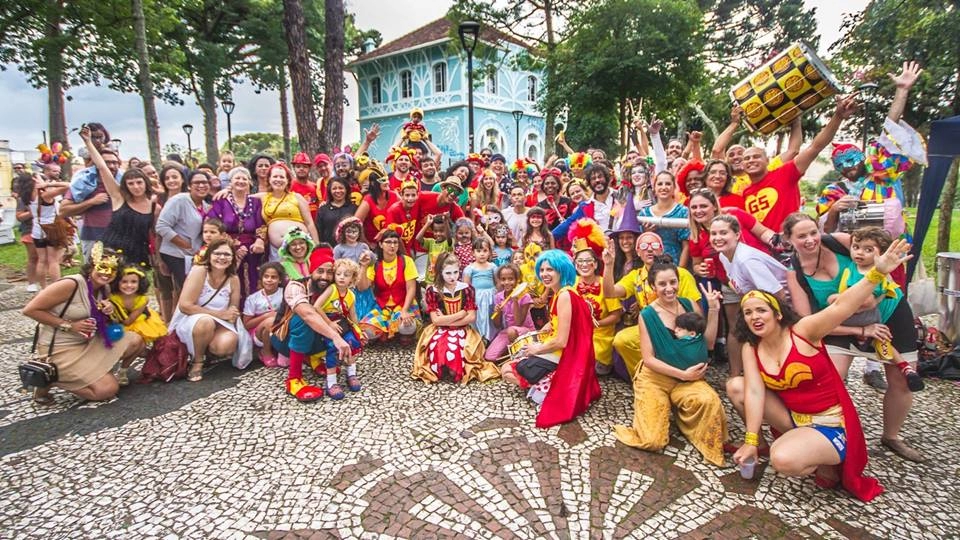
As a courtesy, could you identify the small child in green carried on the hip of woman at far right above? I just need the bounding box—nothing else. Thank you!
[827,227,924,392]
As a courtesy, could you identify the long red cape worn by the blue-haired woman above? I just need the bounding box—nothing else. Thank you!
[537,289,600,428]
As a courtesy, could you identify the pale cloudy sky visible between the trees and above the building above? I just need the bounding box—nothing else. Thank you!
[0,0,869,159]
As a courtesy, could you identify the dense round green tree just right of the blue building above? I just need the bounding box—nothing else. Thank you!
[547,0,703,151]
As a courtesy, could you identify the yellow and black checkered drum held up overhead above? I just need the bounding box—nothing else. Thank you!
[730,43,841,135]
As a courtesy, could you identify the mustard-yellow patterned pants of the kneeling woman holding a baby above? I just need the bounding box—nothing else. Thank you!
[613,370,727,465]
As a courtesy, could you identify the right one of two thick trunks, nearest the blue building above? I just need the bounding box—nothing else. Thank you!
[320,0,345,149]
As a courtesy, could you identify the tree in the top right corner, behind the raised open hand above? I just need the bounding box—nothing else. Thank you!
[834,0,960,251]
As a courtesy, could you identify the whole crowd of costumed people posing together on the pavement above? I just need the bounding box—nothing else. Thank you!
[15,63,925,501]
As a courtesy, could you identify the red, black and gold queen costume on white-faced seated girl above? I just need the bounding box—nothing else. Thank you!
[410,281,500,384]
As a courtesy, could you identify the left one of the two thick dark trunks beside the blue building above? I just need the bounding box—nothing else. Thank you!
[283,0,320,154]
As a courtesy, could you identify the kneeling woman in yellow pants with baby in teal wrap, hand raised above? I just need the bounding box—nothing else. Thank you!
[614,257,727,465]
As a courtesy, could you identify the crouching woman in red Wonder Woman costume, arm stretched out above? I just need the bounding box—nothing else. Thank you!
[727,240,910,502]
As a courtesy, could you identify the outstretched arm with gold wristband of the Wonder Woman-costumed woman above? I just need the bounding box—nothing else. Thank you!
[794,238,913,343]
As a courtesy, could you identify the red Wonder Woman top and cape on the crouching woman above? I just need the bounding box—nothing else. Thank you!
[754,329,883,502]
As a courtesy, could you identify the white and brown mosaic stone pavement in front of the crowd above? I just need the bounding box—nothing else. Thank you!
[0,287,960,539]
